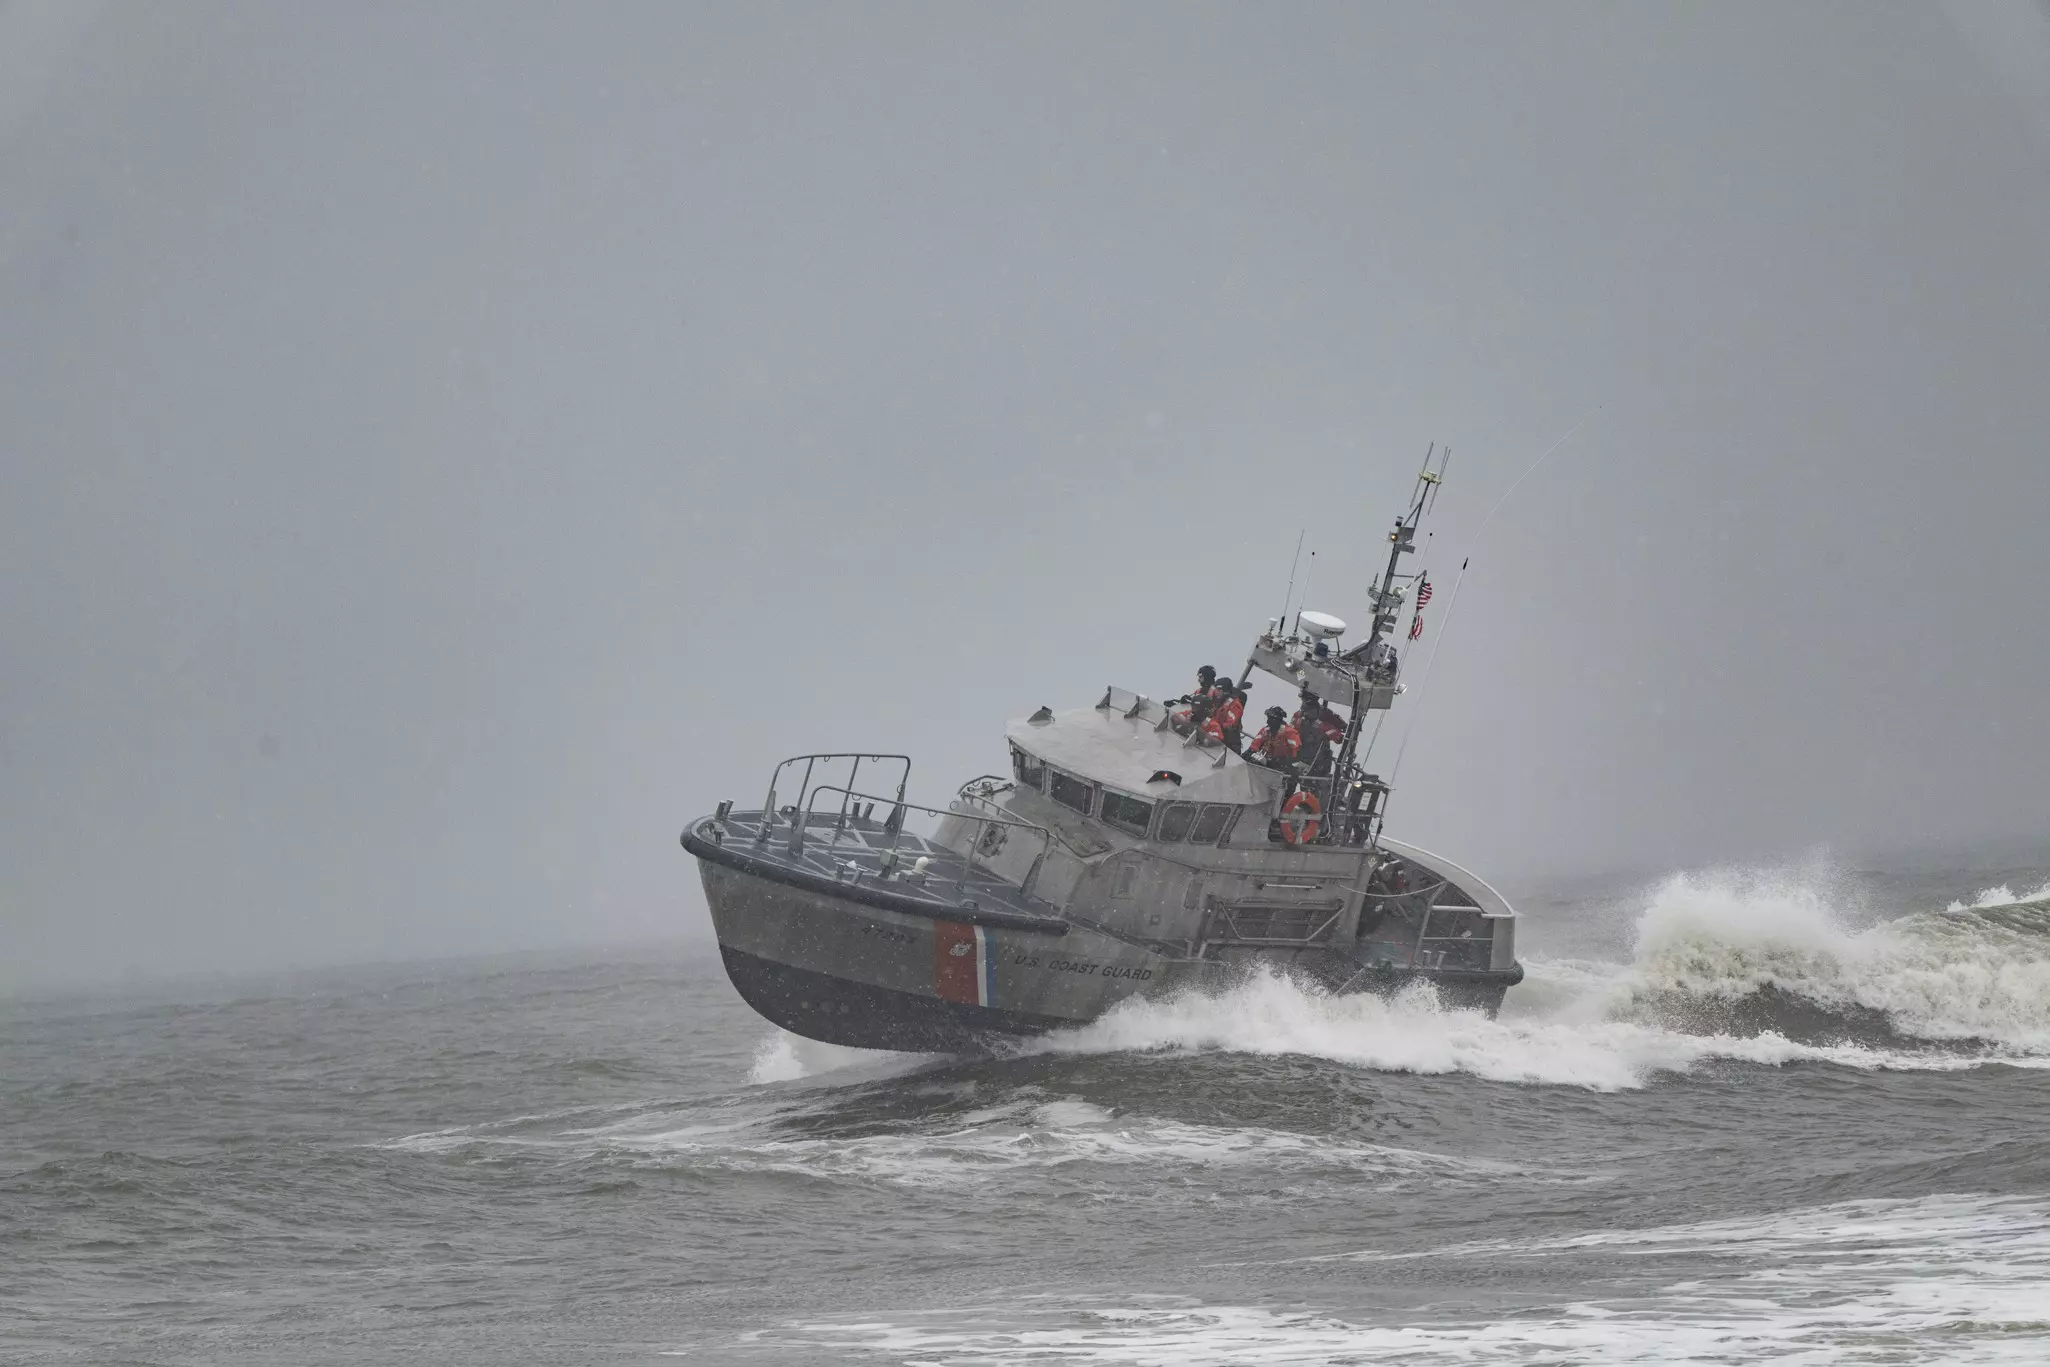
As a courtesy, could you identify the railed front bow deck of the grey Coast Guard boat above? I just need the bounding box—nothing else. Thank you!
[683,812,1068,935]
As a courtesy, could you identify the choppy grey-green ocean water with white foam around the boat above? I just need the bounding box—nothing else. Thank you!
[0,867,2050,1365]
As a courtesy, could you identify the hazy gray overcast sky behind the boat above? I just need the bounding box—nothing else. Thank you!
[0,0,2050,984]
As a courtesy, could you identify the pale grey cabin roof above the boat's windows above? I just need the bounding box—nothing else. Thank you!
[1005,689,1273,803]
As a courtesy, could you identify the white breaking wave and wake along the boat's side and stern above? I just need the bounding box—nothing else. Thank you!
[1023,875,2050,1090]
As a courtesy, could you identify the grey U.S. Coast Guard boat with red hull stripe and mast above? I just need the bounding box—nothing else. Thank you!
[683,461,1523,1051]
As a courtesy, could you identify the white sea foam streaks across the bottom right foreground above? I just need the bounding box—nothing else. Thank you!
[752,1197,2050,1367]
